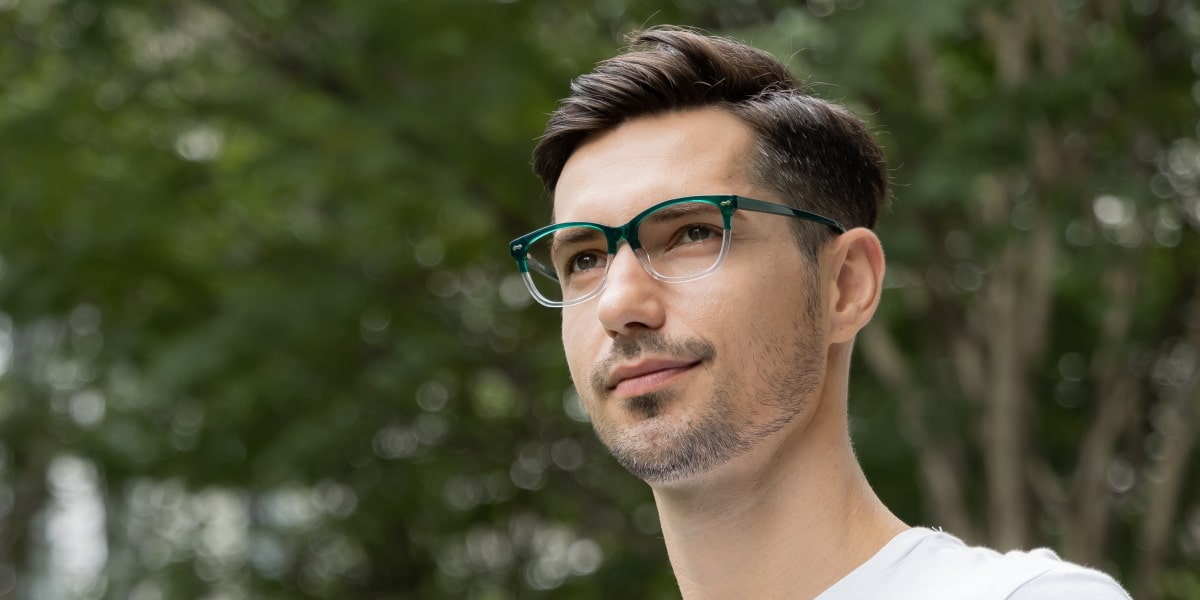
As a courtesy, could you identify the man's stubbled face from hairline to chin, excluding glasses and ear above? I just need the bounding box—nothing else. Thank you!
[554,108,826,482]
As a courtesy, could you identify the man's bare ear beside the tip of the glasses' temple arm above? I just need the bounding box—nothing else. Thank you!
[823,227,884,343]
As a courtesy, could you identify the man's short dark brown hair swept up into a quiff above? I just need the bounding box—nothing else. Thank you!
[533,26,888,253]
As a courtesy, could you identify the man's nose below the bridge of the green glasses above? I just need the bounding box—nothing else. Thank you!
[596,244,666,337]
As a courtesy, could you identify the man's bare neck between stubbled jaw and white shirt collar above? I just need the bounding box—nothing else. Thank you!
[654,350,907,600]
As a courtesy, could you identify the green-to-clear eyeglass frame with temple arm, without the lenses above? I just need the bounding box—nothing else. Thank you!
[509,196,846,307]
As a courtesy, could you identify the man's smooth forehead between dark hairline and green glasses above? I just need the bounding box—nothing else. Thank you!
[554,108,754,224]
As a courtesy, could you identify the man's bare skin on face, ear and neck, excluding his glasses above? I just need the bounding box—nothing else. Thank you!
[554,108,906,599]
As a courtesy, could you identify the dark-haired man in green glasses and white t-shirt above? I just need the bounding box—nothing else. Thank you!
[510,28,1128,600]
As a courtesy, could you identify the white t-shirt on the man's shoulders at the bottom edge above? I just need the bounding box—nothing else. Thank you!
[816,527,1129,600]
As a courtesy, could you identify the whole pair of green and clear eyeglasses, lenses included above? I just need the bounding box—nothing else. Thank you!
[509,196,846,307]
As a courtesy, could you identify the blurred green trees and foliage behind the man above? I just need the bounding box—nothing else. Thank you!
[0,0,1200,600]
